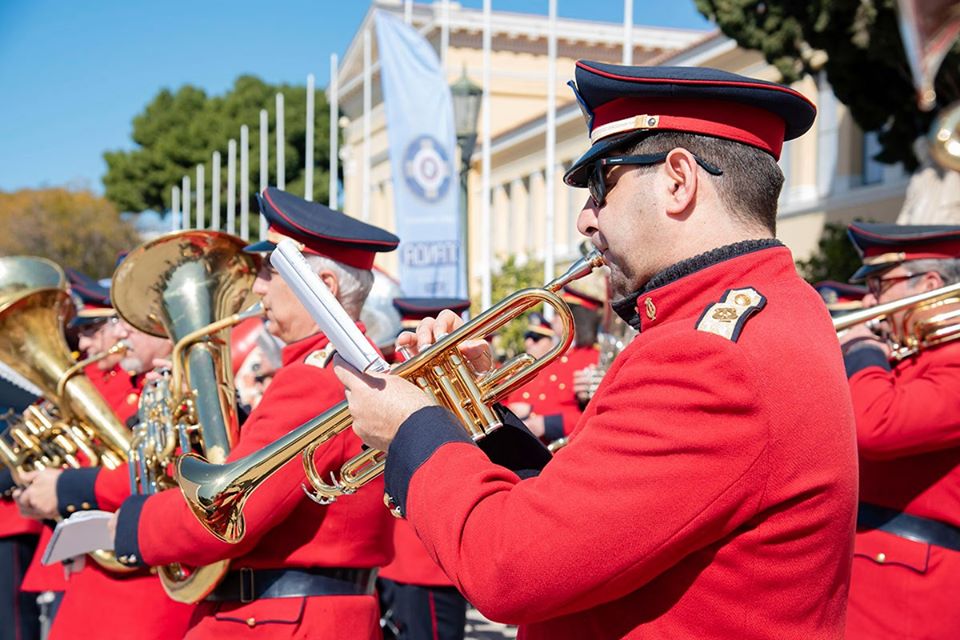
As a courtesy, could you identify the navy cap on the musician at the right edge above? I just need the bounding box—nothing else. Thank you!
[847,222,960,283]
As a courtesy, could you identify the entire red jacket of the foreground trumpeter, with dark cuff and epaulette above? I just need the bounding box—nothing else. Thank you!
[386,241,857,640]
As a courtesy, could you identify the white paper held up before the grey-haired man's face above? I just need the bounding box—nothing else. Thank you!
[270,238,390,372]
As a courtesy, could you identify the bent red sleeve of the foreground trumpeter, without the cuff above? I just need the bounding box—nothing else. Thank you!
[387,333,770,624]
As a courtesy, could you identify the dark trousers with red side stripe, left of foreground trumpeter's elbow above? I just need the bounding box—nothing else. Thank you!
[377,578,467,640]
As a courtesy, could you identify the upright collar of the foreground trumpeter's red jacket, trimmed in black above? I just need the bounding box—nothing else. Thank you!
[614,240,796,331]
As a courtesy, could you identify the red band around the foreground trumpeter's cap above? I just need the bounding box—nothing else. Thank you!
[593,97,786,159]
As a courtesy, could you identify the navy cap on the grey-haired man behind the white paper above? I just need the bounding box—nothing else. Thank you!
[245,187,400,269]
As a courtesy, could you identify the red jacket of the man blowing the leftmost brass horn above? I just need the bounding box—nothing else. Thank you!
[47,367,194,640]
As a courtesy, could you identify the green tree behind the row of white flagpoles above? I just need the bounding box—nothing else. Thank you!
[103,75,330,216]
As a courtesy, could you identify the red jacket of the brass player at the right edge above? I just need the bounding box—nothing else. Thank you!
[847,342,960,640]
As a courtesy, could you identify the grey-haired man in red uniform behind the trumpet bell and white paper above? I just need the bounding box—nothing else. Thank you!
[109,188,398,640]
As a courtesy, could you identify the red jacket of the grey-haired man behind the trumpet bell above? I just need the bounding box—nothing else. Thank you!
[117,334,393,639]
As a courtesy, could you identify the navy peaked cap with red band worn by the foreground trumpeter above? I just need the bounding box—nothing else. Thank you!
[563,60,817,187]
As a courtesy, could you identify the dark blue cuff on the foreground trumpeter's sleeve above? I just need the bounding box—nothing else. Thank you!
[384,407,473,516]
